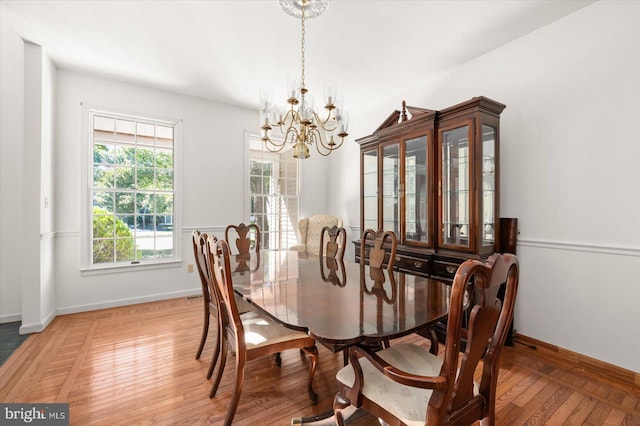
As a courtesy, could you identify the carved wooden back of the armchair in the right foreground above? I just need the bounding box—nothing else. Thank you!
[427,254,519,424]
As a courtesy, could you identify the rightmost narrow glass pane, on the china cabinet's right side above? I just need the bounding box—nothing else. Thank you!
[480,124,496,246]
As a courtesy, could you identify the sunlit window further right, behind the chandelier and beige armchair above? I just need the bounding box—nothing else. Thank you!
[249,136,298,250]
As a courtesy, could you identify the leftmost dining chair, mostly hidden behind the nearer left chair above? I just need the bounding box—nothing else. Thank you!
[191,229,255,378]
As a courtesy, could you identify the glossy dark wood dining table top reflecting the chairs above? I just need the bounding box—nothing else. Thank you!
[231,250,450,351]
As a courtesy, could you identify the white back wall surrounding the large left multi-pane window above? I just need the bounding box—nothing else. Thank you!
[56,70,332,313]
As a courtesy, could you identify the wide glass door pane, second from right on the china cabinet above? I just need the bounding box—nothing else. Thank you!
[440,125,470,247]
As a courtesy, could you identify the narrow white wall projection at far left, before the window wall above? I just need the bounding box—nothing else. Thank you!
[20,42,56,334]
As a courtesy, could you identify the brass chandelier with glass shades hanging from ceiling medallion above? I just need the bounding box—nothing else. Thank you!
[260,0,349,159]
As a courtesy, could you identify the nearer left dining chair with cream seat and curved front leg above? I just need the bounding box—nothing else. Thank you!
[206,239,318,425]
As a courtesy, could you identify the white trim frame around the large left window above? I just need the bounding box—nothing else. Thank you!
[80,103,182,275]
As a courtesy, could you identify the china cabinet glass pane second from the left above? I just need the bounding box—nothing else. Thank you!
[382,144,400,236]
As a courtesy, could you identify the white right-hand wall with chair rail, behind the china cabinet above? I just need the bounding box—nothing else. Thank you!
[336,1,640,372]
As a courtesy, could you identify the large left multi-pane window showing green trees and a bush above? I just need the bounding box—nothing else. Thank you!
[87,111,178,267]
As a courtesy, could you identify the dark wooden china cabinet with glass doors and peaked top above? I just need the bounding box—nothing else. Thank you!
[354,96,512,280]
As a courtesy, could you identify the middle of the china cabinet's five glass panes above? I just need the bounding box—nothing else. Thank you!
[404,136,429,243]
